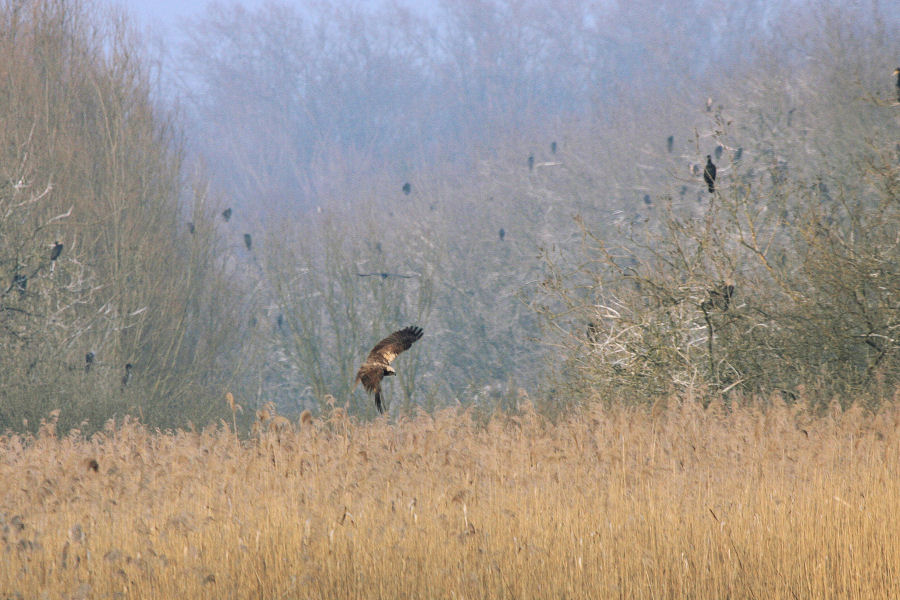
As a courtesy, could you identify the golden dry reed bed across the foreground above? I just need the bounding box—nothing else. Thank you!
[0,401,900,599]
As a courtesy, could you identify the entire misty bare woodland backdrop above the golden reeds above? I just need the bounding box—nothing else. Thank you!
[0,0,900,429]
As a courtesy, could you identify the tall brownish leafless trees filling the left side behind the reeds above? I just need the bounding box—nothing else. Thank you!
[0,0,250,429]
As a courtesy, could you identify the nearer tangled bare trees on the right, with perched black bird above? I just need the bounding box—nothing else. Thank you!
[539,13,900,404]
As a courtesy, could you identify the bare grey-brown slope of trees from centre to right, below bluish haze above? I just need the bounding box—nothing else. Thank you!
[207,0,896,414]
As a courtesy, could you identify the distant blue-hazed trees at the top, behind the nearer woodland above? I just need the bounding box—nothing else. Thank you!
[182,0,791,214]
